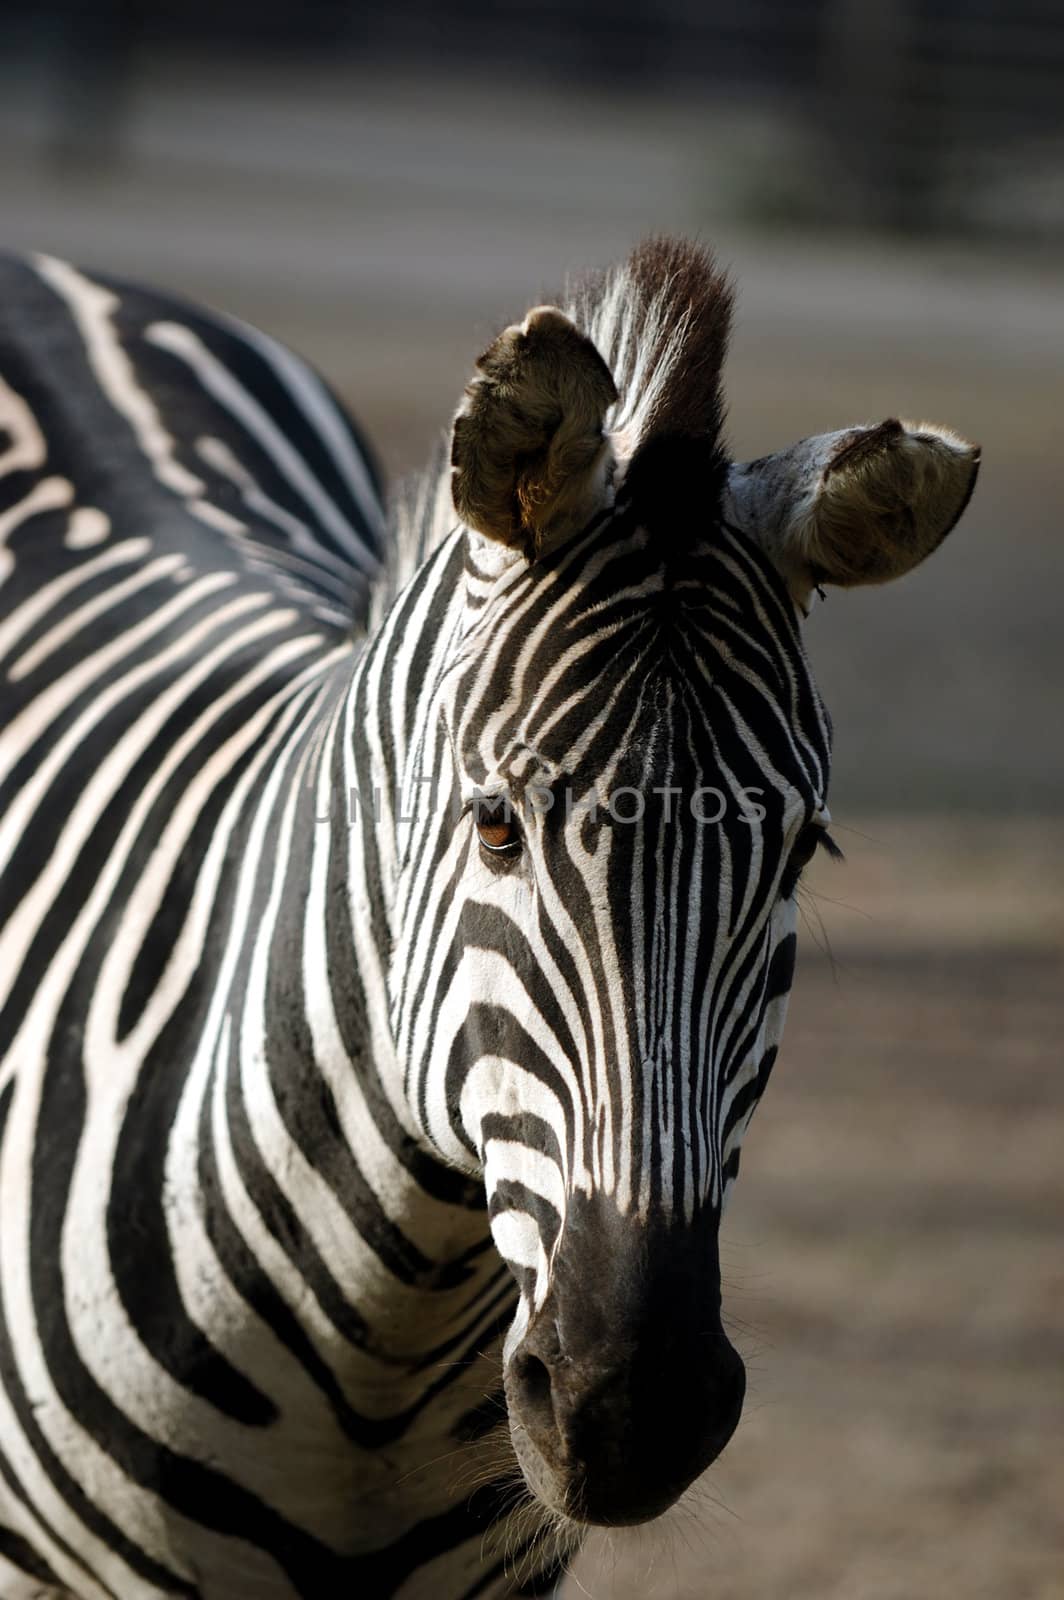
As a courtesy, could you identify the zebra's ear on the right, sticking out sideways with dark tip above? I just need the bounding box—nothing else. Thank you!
[725,419,979,603]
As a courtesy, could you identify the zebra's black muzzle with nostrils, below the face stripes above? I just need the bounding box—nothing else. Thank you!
[506,1195,746,1526]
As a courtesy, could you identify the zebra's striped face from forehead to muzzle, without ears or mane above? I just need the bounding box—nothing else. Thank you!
[427,489,829,1522]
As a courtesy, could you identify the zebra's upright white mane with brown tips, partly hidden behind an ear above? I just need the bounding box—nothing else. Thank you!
[373,237,733,624]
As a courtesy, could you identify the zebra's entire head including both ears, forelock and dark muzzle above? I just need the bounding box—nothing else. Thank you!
[412,243,978,1523]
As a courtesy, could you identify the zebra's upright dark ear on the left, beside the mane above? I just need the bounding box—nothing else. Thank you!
[451,306,618,560]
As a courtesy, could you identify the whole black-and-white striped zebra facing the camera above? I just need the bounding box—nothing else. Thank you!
[0,238,979,1600]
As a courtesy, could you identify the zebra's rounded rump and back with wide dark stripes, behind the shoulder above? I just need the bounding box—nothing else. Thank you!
[0,256,384,642]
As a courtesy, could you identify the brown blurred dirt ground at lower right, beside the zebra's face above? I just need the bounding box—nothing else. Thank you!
[563,821,1064,1600]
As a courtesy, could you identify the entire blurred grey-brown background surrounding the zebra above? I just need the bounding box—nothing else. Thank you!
[0,0,1064,1600]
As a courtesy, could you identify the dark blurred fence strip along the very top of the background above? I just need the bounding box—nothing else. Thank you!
[0,0,1064,237]
